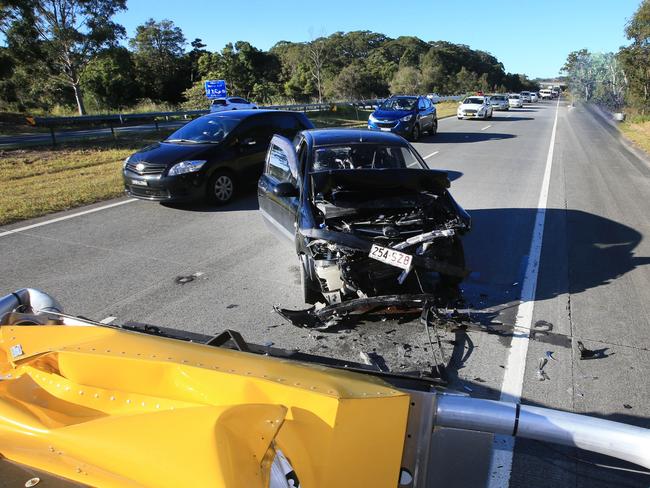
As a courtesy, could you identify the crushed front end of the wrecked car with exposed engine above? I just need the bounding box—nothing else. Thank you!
[308,170,469,304]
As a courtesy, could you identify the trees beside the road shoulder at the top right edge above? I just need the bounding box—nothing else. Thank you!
[562,0,650,114]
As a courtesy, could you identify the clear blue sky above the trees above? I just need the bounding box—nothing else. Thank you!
[116,0,641,78]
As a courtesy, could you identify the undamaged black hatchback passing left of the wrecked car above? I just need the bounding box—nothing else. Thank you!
[122,110,314,205]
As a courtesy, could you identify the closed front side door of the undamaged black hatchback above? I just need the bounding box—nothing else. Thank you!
[234,113,274,181]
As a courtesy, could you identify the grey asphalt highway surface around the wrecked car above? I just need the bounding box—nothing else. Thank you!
[0,102,650,487]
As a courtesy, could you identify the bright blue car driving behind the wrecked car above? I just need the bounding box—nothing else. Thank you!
[368,96,438,141]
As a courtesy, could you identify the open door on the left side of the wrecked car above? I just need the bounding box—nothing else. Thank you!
[257,135,300,242]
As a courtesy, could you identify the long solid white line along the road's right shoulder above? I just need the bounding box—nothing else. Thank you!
[488,99,560,488]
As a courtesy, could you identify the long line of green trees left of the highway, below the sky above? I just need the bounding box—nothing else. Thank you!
[0,0,538,114]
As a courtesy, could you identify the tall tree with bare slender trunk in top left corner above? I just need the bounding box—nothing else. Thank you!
[0,0,126,115]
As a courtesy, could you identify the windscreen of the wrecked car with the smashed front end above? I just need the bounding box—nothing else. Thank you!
[311,143,425,171]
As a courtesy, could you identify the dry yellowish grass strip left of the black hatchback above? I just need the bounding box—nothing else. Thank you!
[0,135,163,225]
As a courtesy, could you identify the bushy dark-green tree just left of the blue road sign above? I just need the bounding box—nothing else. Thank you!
[129,19,191,103]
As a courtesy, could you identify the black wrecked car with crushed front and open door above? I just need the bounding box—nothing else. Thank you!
[258,129,470,305]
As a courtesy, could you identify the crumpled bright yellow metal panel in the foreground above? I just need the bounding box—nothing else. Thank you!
[0,326,409,488]
